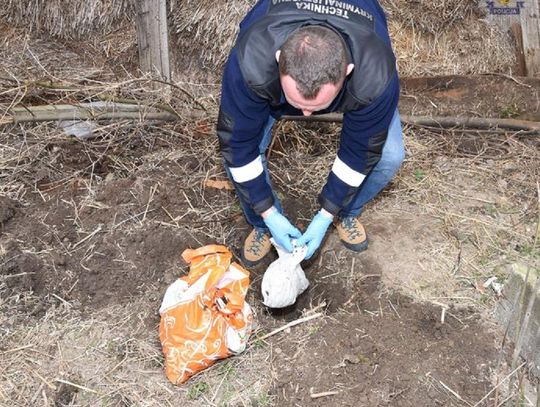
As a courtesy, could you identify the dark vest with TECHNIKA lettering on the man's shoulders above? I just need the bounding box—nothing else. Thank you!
[237,0,396,112]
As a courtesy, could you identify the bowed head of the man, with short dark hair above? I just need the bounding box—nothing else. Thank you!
[276,25,354,116]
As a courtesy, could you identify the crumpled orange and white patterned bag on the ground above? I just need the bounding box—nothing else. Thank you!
[159,245,253,384]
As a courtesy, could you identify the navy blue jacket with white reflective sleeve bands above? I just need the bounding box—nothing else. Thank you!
[217,0,399,214]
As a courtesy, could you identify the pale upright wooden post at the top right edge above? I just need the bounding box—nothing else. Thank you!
[521,0,540,76]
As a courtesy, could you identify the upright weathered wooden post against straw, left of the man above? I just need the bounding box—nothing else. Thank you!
[135,0,171,82]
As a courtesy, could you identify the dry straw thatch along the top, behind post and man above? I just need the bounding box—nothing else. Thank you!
[0,0,515,78]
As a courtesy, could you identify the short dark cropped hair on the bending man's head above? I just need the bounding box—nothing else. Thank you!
[279,25,347,99]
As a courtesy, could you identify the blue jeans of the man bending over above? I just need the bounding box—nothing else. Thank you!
[224,109,405,231]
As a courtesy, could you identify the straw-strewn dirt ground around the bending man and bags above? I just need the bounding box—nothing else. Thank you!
[0,21,540,406]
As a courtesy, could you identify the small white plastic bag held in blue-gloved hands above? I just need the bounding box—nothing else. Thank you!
[261,239,309,308]
